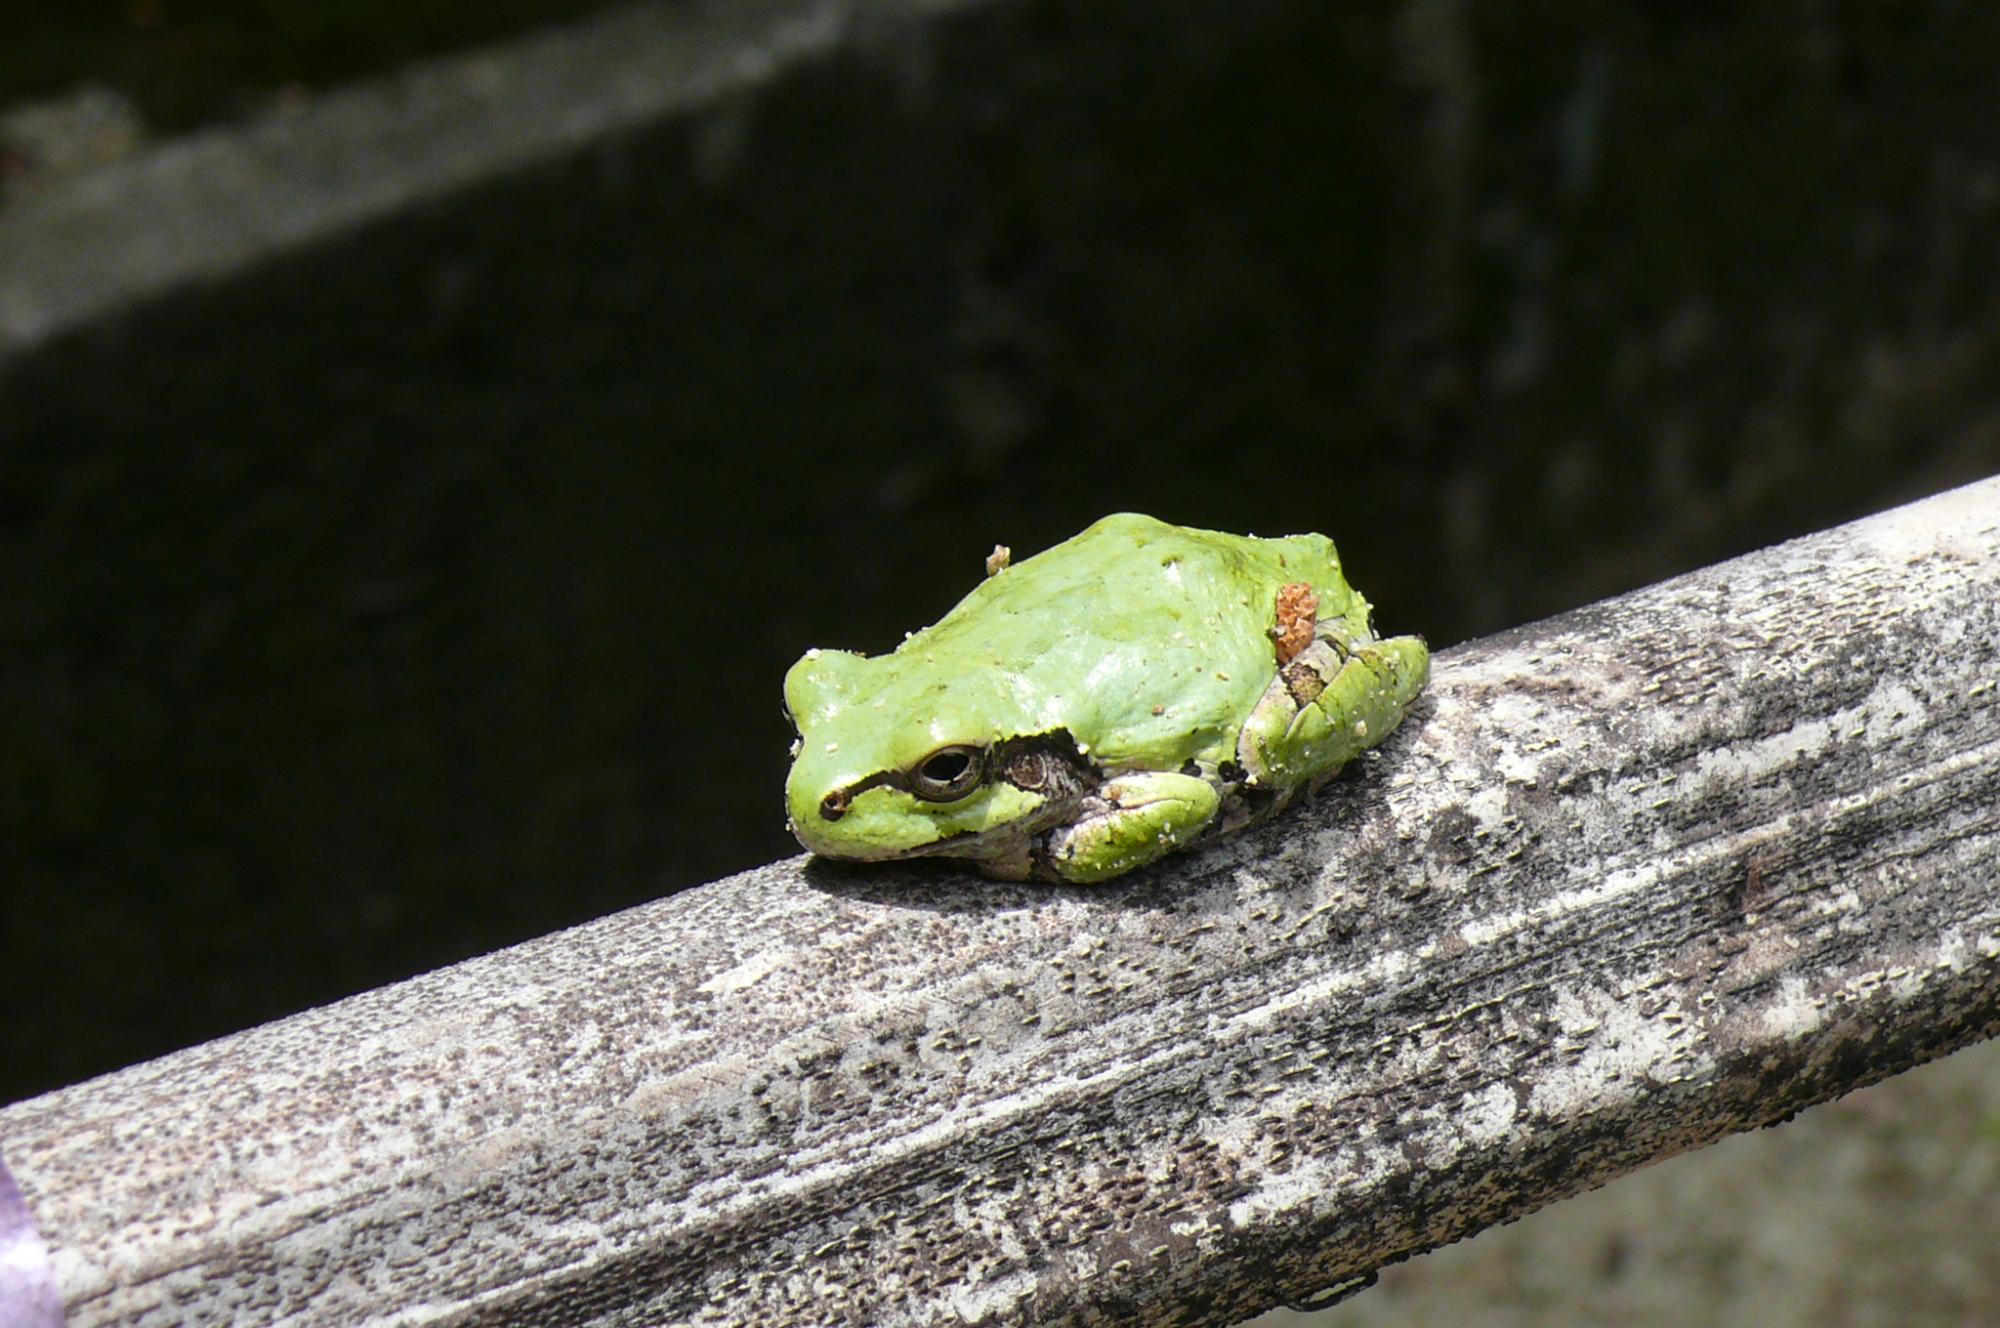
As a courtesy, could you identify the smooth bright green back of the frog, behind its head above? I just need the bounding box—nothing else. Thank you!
[898,512,1348,766]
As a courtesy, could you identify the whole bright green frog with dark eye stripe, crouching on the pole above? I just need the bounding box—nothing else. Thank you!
[784,514,1430,882]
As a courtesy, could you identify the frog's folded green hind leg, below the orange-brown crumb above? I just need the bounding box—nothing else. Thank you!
[1236,622,1430,792]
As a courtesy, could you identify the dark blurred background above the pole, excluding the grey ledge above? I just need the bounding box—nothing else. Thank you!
[0,0,2000,1100]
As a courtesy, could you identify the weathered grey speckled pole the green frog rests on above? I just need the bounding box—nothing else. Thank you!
[0,480,2000,1326]
